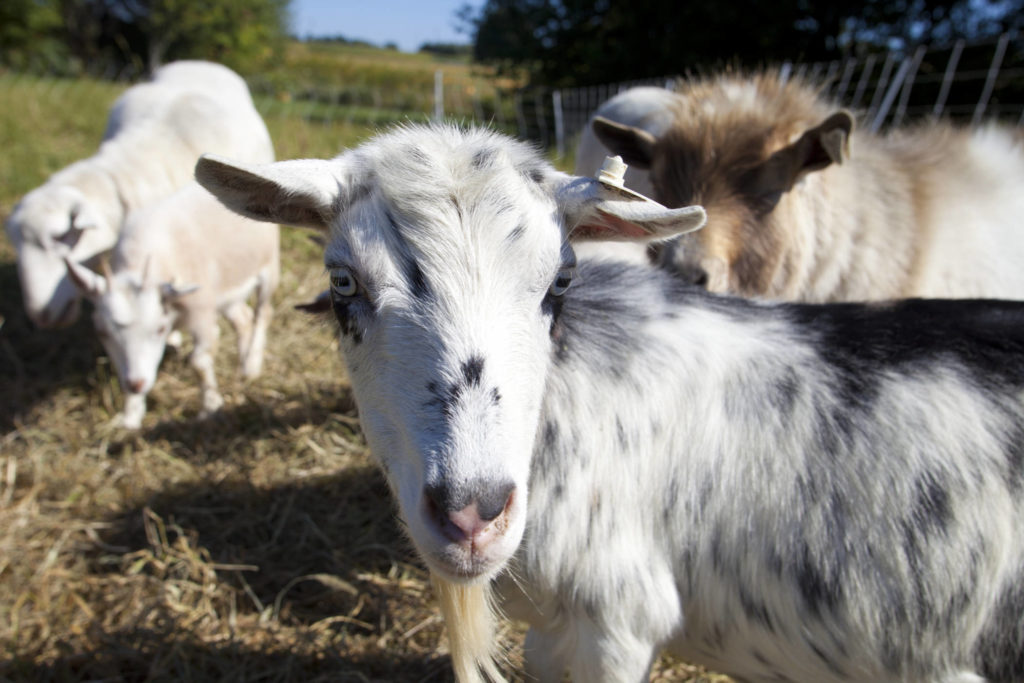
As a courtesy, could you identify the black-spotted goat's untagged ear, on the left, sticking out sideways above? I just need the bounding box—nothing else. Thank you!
[196,155,346,229]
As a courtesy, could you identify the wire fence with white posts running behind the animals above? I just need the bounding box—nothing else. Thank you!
[0,34,1024,157]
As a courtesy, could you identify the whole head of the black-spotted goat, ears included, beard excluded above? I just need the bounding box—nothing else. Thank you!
[197,128,703,580]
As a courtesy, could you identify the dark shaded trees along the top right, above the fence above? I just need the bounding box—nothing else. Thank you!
[460,0,1024,86]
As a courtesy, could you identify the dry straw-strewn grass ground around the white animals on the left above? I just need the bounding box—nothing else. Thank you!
[0,62,720,682]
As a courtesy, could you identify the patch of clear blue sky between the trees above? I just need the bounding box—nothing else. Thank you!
[291,0,484,52]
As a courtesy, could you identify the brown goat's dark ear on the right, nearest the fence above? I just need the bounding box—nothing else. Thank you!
[753,110,853,195]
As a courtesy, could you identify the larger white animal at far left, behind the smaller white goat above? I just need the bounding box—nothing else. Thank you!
[7,61,273,328]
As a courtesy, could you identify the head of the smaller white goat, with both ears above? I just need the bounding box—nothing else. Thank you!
[68,262,191,395]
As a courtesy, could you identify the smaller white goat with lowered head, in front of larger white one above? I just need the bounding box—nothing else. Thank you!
[68,182,280,429]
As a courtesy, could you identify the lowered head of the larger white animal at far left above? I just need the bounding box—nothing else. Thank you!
[6,186,117,328]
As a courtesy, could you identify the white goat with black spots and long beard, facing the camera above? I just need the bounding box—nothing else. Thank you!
[197,127,1024,683]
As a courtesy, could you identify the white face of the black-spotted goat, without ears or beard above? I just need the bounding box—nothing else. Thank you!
[325,160,571,578]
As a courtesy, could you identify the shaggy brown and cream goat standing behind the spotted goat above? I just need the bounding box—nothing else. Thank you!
[593,72,1024,301]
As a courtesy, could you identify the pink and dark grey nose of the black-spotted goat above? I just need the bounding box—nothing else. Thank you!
[425,482,515,548]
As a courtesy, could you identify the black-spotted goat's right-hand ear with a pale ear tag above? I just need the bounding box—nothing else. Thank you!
[552,173,707,242]
